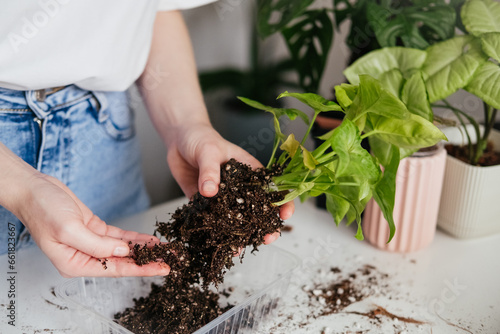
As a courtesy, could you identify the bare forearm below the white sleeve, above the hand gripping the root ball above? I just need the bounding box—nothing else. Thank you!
[138,11,210,146]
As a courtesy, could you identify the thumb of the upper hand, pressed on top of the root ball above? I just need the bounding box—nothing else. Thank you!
[197,145,221,197]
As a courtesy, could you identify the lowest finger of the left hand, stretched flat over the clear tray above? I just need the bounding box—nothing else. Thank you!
[61,253,170,277]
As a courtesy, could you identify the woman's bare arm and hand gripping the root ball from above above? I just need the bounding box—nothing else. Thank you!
[137,11,294,243]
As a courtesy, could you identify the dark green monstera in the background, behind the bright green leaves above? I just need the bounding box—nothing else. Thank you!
[254,0,463,219]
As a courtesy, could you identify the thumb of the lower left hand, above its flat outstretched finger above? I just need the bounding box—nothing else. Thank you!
[60,216,133,258]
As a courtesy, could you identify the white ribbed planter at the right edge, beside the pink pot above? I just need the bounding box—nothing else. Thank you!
[438,131,500,239]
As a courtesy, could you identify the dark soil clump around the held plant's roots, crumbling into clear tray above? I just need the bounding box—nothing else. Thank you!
[115,159,284,333]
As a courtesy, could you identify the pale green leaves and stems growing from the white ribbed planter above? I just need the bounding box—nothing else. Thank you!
[344,0,500,165]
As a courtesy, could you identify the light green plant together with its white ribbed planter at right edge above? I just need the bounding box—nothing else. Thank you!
[345,0,500,238]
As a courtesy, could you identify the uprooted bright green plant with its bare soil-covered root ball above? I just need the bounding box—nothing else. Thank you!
[117,75,444,333]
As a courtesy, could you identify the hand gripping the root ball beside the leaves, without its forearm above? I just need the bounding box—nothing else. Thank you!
[167,123,295,244]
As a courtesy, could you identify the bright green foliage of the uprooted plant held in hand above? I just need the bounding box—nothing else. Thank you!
[240,75,446,241]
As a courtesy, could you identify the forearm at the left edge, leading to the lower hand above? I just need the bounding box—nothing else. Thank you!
[0,142,39,215]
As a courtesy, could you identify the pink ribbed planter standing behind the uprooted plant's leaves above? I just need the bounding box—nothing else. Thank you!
[363,146,446,252]
